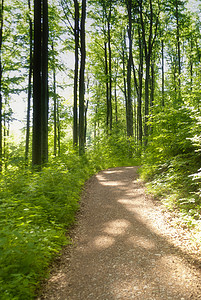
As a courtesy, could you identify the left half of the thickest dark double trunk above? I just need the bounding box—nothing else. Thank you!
[32,0,42,169]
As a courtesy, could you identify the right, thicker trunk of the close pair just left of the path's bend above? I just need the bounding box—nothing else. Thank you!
[79,0,86,155]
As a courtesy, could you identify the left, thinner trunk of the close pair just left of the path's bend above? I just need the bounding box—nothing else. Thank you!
[73,0,79,146]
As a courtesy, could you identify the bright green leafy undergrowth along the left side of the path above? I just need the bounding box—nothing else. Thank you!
[0,140,141,300]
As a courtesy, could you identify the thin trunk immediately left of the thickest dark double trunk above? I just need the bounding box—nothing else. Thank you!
[25,0,33,165]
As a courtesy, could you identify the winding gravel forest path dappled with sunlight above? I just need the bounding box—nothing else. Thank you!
[37,167,201,300]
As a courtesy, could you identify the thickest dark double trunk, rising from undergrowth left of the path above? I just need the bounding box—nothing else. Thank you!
[32,0,48,167]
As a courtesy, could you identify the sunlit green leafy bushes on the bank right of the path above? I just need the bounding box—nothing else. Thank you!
[141,107,201,226]
